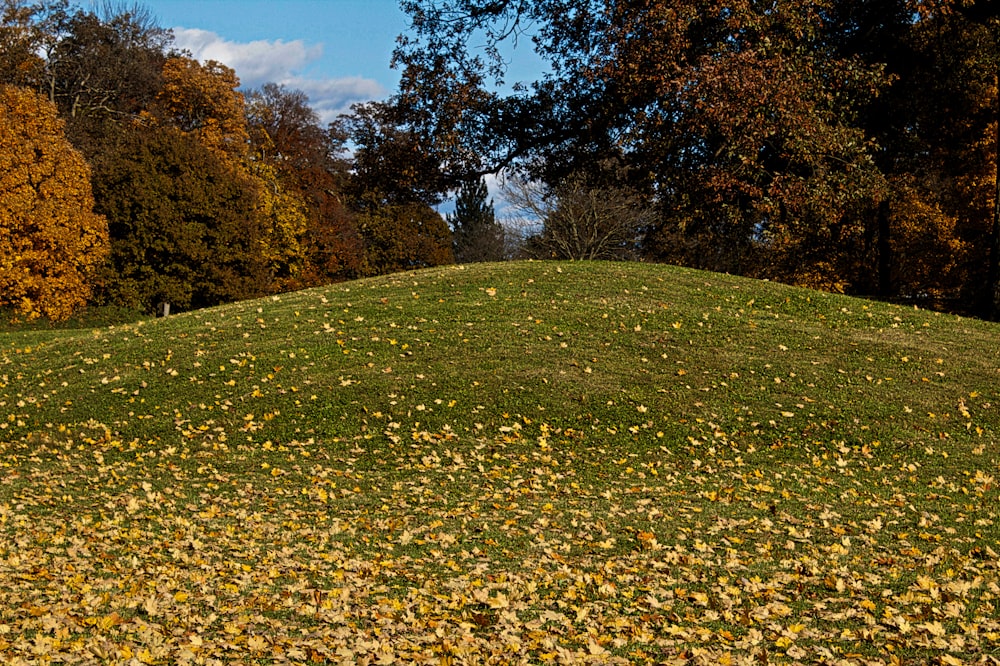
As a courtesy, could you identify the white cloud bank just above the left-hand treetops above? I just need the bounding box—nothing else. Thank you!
[173,28,388,124]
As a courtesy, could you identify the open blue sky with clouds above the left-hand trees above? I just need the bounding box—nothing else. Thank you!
[138,0,408,122]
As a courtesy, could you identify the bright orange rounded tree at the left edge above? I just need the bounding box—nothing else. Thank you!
[0,85,108,319]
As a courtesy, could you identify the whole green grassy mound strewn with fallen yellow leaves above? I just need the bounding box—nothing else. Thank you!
[0,263,1000,665]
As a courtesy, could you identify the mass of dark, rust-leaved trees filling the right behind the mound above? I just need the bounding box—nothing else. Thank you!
[386,0,1000,318]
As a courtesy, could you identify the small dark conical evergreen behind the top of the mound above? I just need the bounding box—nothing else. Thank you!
[447,179,505,263]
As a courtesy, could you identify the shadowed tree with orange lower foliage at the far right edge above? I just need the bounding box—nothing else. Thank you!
[825,0,995,307]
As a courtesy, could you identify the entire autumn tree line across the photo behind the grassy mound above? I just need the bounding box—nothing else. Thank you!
[0,0,1000,318]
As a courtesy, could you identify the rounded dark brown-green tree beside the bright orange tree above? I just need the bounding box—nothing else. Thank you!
[94,127,272,311]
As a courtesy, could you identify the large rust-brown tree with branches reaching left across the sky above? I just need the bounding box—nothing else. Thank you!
[394,0,884,282]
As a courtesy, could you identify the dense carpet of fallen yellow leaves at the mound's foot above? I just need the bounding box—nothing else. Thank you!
[0,422,1000,664]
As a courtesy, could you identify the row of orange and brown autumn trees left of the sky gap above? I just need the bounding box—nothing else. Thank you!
[0,0,504,319]
